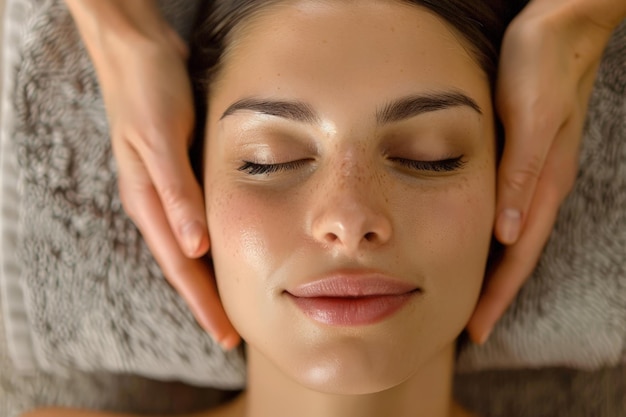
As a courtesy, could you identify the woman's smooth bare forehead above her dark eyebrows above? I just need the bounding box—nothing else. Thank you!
[214,0,488,118]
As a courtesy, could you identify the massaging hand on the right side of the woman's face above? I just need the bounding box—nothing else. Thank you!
[468,0,626,343]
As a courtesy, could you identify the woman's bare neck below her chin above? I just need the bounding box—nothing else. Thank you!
[244,346,457,417]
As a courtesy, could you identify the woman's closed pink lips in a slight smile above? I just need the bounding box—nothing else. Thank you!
[286,274,421,326]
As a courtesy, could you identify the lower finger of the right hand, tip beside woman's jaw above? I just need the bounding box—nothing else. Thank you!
[467,177,562,344]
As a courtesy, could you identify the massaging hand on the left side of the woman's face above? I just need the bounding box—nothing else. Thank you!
[66,0,239,348]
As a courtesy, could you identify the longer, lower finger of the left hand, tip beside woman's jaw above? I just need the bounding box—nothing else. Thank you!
[117,145,240,349]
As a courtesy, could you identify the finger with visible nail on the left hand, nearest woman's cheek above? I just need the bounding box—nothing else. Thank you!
[137,125,209,257]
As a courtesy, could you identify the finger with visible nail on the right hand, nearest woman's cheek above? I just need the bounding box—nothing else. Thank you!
[495,83,565,245]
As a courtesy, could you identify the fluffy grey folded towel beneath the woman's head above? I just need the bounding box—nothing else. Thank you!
[0,0,626,388]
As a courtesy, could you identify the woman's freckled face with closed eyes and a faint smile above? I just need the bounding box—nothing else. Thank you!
[204,0,495,393]
